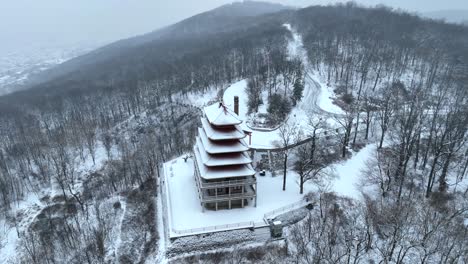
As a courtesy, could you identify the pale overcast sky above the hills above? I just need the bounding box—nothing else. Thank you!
[0,0,468,53]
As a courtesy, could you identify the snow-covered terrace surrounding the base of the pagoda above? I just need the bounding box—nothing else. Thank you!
[164,158,314,232]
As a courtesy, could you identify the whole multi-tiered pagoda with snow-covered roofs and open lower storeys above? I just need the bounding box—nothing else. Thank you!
[193,98,257,211]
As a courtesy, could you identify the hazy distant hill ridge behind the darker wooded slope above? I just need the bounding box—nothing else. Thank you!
[21,1,290,92]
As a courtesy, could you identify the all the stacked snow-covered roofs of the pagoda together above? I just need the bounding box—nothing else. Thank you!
[194,103,255,180]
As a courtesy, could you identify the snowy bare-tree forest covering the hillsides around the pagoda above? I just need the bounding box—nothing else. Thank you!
[0,2,468,264]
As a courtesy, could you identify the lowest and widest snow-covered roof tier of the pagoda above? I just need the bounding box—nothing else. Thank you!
[194,146,255,180]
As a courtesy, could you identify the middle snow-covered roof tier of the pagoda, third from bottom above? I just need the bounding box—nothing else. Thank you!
[198,128,249,154]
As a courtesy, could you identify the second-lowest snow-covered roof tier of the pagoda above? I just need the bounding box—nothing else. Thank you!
[196,137,252,167]
